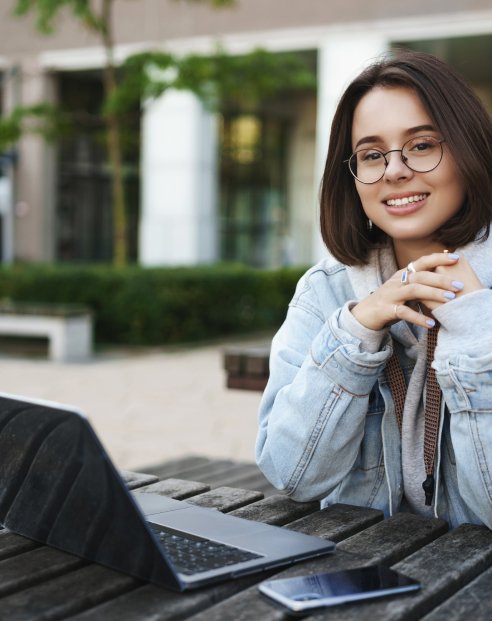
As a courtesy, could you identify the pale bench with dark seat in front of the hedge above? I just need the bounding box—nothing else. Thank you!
[0,302,92,362]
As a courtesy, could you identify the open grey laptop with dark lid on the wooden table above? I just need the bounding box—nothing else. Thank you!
[0,393,335,591]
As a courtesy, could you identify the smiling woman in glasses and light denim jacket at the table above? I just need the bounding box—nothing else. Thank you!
[257,52,492,528]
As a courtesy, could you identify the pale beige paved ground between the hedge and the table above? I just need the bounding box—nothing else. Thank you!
[0,345,266,469]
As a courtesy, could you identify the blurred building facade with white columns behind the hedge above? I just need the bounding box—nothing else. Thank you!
[0,0,492,267]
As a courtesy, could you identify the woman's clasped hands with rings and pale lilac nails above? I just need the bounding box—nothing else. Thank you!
[352,252,482,330]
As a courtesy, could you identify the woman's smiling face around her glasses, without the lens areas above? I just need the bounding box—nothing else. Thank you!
[352,87,465,254]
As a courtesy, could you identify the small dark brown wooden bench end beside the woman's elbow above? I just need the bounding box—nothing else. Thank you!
[224,343,270,391]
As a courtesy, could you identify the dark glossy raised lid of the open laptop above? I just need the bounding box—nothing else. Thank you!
[0,396,177,586]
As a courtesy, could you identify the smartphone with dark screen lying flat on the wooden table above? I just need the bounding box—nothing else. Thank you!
[258,565,420,614]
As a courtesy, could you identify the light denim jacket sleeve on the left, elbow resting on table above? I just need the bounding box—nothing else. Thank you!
[256,272,391,500]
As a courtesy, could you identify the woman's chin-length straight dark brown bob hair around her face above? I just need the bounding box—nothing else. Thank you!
[320,50,492,265]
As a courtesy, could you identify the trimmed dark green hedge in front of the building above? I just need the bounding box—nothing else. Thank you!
[0,265,304,345]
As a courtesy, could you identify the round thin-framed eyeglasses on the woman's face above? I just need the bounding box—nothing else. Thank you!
[344,136,444,184]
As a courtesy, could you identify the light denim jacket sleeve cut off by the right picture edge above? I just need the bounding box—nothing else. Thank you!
[433,289,492,528]
